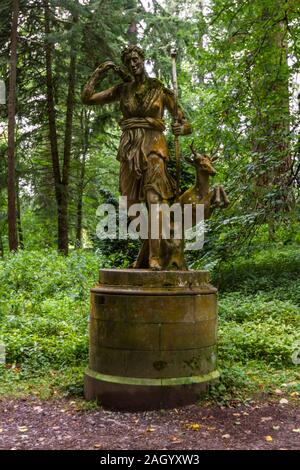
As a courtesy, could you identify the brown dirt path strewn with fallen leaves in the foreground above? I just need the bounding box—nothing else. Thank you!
[0,399,300,450]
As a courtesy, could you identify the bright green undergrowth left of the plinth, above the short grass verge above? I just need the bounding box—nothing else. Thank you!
[0,251,101,374]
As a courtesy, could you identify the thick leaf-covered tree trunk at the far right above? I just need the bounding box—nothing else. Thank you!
[253,0,293,224]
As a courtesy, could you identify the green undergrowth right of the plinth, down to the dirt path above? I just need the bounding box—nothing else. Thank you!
[211,245,300,403]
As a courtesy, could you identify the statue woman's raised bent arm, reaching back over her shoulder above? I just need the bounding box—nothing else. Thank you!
[81,61,125,105]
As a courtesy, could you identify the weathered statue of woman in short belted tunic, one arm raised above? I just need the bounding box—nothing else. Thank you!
[82,45,191,270]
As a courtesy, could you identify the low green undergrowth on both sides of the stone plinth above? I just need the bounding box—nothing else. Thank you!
[0,246,300,404]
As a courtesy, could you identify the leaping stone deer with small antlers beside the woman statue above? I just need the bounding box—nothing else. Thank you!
[179,144,229,225]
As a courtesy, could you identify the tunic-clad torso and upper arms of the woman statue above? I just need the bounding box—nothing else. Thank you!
[85,77,187,204]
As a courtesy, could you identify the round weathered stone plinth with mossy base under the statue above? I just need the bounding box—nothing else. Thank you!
[85,269,219,410]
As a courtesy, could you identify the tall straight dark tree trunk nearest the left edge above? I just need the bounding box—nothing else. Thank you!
[7,0,19,251]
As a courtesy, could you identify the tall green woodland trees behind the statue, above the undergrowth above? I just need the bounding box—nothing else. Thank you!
[0,0,300,264]
